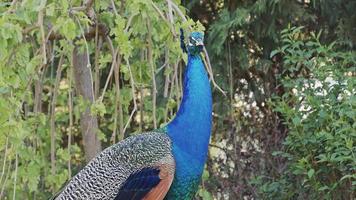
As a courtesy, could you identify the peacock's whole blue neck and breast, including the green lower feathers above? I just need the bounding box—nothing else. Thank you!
[165,52,212,200]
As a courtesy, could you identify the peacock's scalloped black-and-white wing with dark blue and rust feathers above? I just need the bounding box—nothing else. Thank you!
[56,132,175,200]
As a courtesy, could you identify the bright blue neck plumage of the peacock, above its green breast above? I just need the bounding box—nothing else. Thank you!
[167,55,212,165]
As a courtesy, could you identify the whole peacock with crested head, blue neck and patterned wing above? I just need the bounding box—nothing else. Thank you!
[55,30,212,200]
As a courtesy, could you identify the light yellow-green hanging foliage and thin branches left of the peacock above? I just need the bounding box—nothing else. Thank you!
[0,0,202,199]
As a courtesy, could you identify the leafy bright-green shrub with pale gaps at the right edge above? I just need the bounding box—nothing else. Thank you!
[252,27,356,199]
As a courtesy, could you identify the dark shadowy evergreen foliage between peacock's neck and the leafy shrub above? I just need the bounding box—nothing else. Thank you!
[185,0,356,199]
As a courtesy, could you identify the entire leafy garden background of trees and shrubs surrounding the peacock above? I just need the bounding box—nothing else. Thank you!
[0,0,356,200]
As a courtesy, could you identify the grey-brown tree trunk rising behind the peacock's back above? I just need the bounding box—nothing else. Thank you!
[73,47,101,161]
